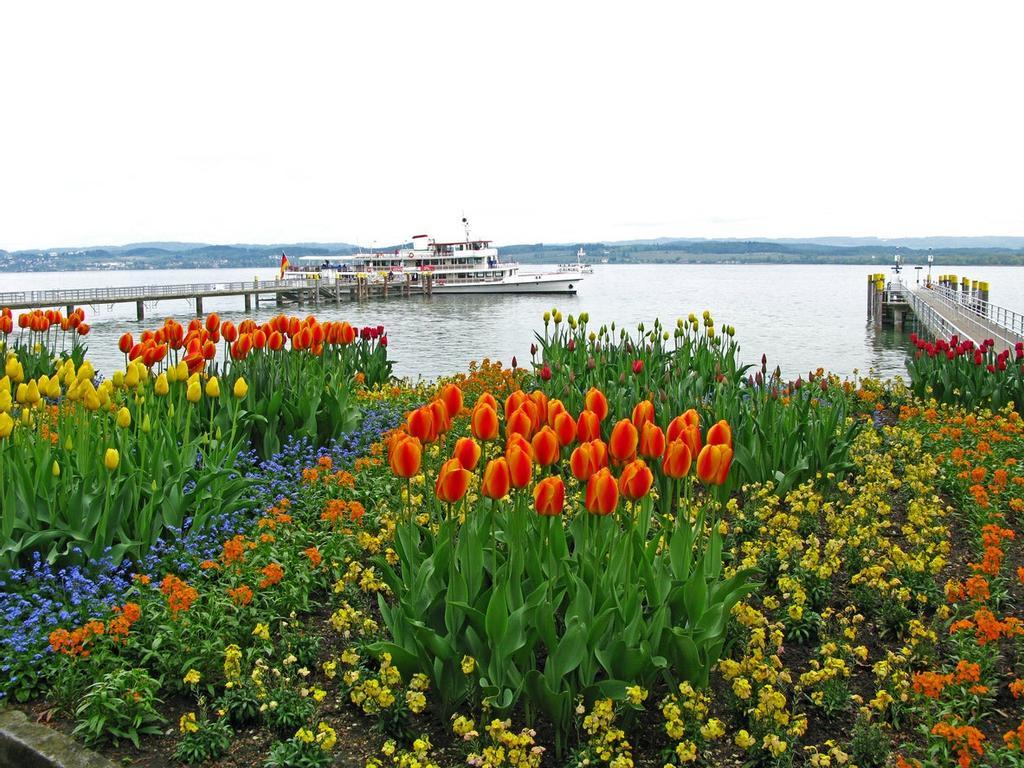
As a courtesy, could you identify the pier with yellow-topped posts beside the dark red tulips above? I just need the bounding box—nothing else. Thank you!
[867,274,1024,351]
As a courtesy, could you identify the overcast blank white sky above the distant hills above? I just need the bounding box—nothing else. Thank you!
[0,0,1024,250]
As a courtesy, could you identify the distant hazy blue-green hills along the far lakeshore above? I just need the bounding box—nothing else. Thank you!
[0,237,1024,271]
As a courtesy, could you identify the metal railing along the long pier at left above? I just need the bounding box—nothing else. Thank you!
[0,279,316,306]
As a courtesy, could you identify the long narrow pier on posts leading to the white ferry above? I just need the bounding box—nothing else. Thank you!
[0,273,433,321]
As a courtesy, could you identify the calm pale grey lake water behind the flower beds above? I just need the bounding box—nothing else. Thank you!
[0,264,1024,378]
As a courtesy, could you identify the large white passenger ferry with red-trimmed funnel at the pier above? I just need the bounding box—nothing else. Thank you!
[288,219,583,294]
